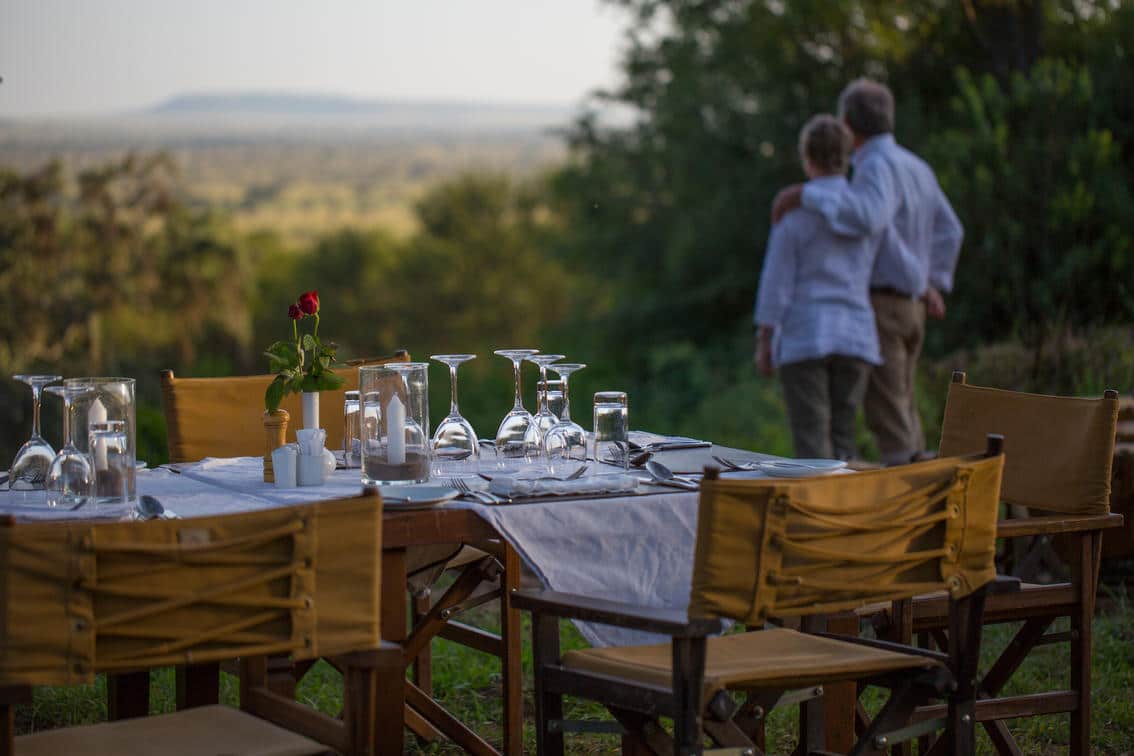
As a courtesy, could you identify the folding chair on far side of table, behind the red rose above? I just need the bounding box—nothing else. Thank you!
[158,349,518,742]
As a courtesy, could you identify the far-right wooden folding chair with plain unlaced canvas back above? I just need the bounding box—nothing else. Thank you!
[870,372,1123,754]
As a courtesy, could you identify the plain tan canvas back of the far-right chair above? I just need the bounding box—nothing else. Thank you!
[941,373,1118,515]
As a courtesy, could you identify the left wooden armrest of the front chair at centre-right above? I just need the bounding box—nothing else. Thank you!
[511,591,725,638]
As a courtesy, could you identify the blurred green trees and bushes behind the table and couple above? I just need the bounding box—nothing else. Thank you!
[0,0,1134,462]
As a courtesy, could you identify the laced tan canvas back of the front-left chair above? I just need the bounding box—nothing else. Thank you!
[0,495,382,687]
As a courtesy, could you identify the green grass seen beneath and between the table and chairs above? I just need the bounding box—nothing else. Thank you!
[16,593,1134,756]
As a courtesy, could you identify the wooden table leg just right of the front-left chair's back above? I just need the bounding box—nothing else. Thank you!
[373,549,407,756]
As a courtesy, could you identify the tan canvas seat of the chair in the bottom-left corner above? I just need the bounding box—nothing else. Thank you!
[16,706,333,756]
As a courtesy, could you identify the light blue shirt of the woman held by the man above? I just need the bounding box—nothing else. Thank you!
[754,176,882,367]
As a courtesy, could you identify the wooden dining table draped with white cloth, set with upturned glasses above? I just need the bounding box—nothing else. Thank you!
[0,442,857,754]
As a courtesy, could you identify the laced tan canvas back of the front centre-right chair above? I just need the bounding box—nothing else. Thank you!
[689,456,1002,626]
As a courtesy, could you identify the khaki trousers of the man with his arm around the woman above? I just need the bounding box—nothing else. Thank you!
[863,294,925,465]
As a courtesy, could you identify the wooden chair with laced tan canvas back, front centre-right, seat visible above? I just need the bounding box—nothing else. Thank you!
[513,439,1002,754]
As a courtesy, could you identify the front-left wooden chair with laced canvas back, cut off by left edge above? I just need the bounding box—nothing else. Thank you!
[0,492,404,756]
